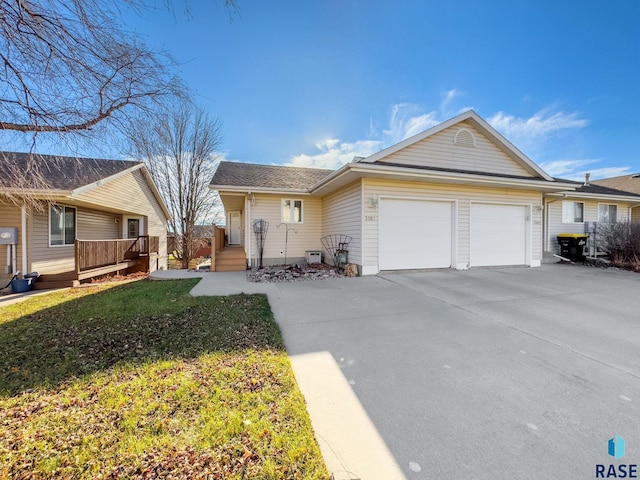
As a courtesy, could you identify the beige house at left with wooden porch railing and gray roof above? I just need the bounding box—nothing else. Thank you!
[0,152,169,287]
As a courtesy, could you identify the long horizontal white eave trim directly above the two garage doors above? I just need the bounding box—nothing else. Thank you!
[340,164,572,190]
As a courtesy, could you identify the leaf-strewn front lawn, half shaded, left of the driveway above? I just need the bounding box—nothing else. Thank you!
[0,279,329,480]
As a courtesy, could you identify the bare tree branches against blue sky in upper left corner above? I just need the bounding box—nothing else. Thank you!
[0,0,183,133]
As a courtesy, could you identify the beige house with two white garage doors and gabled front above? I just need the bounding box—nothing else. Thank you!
[210,111,640,275]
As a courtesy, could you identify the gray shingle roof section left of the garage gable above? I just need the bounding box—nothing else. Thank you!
[211,162,333,190]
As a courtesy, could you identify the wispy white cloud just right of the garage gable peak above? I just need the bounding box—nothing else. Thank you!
[487,109,589,143]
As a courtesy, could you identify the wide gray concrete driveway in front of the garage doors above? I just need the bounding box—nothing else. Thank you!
[265,265,640,480]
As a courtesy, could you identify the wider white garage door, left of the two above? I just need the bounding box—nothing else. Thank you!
[379,199,453,270]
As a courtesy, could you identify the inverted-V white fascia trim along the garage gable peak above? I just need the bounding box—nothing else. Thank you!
[358,110,553,182]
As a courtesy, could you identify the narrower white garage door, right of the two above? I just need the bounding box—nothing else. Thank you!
[470,203,527,267]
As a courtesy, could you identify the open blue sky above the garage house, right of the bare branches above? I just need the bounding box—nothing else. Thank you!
[11,0,640,178]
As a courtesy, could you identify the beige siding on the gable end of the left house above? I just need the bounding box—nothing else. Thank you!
[75,170,167,271]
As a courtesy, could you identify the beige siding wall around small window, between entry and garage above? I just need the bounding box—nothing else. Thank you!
[245,194,322,265]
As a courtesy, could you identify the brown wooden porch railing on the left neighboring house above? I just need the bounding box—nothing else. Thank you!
[75,235,160,273]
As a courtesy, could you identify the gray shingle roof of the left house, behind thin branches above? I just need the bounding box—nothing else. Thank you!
[0,152,139,190]
